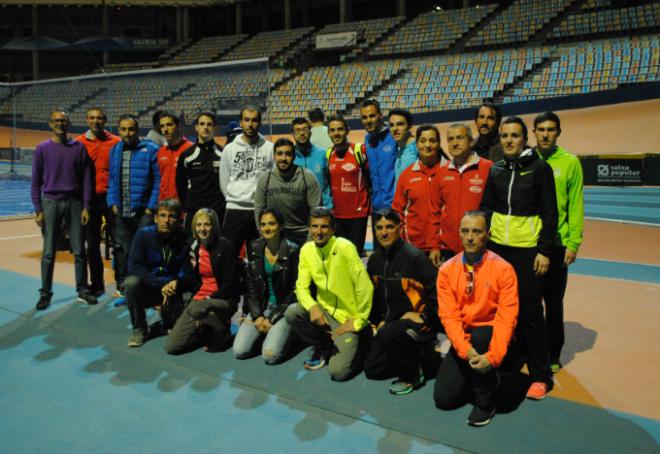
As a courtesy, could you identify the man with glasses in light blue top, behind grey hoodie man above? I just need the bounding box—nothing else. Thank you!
[291,117,332,208]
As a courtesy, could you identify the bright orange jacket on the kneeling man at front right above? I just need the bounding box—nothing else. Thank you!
[437,250,518,367]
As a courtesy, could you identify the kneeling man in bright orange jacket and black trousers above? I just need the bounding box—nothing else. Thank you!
[433,211,518,427]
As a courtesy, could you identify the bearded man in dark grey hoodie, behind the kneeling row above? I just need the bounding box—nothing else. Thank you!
[254,138,321,246]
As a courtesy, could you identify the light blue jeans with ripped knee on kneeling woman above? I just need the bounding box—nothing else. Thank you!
[232,315,291,365]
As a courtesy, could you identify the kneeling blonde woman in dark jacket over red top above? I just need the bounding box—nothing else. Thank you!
[165,208,239,355]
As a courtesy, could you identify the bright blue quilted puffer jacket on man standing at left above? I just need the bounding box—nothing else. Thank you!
[107,140,160,212]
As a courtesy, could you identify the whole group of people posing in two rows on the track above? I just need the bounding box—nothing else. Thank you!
[32,99,584,426]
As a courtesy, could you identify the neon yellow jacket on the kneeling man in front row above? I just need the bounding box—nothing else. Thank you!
[296,236,374,331]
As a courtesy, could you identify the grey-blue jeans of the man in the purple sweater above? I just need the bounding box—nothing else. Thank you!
[39,197,87,296]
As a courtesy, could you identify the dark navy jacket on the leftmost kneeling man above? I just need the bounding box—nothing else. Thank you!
[128,225,188,288]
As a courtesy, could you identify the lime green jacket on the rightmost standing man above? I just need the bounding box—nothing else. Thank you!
[537,146,584,252]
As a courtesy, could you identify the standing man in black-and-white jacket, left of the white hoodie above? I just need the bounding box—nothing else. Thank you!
[176,112,226,237]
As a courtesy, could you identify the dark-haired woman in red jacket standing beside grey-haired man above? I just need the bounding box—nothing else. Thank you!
[392,125,444,253]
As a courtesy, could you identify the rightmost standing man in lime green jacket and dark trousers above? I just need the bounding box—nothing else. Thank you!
[534,112,584,373]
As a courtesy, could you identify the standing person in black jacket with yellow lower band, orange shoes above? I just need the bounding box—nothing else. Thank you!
[481,117,558,400]
